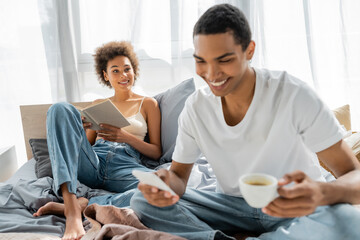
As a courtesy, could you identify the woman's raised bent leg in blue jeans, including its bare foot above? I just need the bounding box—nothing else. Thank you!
[47,103,100,239]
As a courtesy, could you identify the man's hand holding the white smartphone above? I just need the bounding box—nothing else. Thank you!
[138,169,179,207]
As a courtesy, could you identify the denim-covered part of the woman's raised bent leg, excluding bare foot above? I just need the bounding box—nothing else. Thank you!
[46,103,101,194]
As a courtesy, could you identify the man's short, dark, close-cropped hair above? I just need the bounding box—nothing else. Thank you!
[193,4,251,51]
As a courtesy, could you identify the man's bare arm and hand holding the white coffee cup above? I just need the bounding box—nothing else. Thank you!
[263,140,360,217]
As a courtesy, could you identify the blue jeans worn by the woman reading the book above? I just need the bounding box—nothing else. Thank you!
[46,103,151,199]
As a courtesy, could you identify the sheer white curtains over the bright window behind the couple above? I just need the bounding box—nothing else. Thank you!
[0,0,360,168]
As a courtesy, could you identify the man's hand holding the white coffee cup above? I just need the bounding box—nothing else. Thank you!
[262,171,324,218]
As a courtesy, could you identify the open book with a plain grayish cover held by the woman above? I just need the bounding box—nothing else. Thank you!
[76,99,130,130]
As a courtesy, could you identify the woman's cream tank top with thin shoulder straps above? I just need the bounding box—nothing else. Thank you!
[122,97,147,140]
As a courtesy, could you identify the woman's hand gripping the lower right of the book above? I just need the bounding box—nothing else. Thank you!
[96,123,132,143]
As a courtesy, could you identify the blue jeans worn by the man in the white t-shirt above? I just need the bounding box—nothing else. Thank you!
[130,188,360,240]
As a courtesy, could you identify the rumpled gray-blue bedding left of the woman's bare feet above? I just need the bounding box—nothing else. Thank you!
[0,178,65,236]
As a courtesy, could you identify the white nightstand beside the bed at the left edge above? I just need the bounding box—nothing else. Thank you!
[0,146,17,182]
